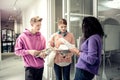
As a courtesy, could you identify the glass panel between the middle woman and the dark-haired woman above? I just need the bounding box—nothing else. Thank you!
[63,0,93,79]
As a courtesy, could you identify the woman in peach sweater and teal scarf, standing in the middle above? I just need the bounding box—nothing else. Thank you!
[49,19,75,80]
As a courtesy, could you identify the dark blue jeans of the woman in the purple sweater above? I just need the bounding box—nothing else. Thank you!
[74,68,94,80]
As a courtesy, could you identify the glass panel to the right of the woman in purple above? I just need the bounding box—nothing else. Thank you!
[98,0,120,80]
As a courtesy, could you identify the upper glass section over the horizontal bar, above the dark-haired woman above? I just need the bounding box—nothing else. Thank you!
[70,0,93,15]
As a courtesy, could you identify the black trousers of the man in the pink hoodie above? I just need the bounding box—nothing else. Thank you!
[25,67,44,80]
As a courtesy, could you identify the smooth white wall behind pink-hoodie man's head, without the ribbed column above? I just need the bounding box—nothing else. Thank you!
[21,0,47,38]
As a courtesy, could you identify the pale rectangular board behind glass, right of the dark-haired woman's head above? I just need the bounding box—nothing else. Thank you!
[104,25,120,51]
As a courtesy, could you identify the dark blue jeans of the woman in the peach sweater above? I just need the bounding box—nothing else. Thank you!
[54,64,71,80]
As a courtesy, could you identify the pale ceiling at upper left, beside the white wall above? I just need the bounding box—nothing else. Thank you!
[0,0,34,21]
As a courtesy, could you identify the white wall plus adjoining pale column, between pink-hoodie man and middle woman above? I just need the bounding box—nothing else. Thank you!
[20,0,55,80]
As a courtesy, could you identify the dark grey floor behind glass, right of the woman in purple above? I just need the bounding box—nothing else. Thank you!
[98,63,120,80]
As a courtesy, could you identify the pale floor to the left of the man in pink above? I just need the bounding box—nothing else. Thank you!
[0,53,24,80]
